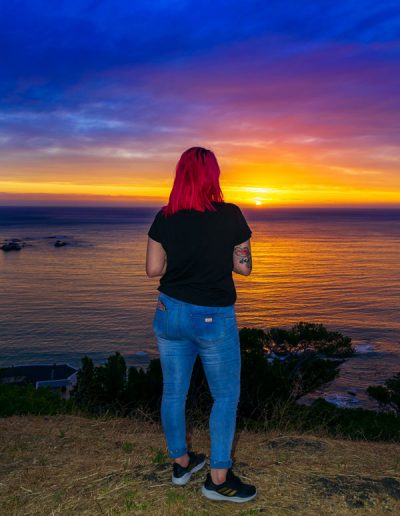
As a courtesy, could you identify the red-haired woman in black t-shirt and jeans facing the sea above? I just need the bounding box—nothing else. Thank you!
[146,147,256,502]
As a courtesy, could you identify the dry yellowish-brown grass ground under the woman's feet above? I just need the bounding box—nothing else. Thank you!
[0,415,400,516]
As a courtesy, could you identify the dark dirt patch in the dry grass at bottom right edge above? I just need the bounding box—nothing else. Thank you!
[311,475,400,508]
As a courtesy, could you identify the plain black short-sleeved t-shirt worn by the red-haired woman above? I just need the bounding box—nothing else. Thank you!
[147,201,252,306]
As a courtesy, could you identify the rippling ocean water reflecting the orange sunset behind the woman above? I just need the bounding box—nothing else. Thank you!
[0,206,400,408]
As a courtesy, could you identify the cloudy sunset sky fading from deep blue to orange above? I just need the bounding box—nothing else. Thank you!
[0,0,400,207]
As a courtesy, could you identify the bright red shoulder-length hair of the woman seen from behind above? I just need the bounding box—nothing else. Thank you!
[162,147,224,216]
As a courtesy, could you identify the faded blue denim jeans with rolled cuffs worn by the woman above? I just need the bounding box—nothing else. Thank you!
[153,292,240,469]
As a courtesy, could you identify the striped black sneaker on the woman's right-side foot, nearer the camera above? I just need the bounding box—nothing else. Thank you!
[201,469,257,503]
